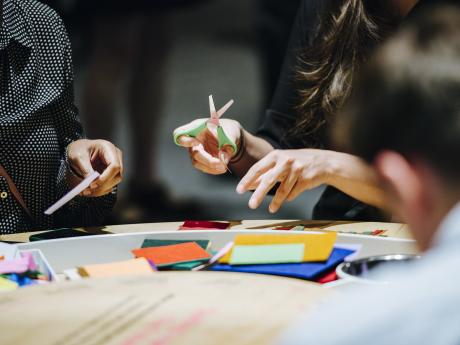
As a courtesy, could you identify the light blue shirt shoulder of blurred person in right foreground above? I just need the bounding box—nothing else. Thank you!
[282,255,460,345]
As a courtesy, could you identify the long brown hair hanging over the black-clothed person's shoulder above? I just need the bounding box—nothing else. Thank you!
[292,0,391,147]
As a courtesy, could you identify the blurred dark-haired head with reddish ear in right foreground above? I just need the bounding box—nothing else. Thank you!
[335,6,460,250]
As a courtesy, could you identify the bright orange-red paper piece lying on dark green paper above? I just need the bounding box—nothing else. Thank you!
[132,242,211,267]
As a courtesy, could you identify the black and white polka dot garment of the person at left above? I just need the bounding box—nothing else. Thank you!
[0,0,116,234]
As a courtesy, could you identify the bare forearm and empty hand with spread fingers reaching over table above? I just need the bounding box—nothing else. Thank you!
[237,149,386,213]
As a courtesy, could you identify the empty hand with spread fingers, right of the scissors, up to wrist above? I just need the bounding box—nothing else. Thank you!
[236,149,334,213]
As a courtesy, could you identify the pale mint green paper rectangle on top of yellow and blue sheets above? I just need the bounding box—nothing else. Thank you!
[229,243,305,265]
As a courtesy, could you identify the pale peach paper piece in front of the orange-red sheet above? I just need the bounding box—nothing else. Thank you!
[78,258,154,278]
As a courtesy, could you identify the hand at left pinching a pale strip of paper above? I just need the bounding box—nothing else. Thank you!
[67,139,123,197]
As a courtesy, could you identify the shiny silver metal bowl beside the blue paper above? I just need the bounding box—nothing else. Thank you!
[336,254,420,283]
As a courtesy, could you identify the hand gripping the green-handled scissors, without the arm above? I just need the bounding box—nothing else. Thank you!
[174,119,242,175]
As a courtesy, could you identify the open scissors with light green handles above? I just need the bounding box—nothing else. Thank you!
[174,95,238,155]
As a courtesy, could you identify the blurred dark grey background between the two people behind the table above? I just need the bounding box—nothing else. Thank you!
[42,0,321,223]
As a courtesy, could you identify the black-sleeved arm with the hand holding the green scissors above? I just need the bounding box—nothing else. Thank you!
[172,0,322,176]
